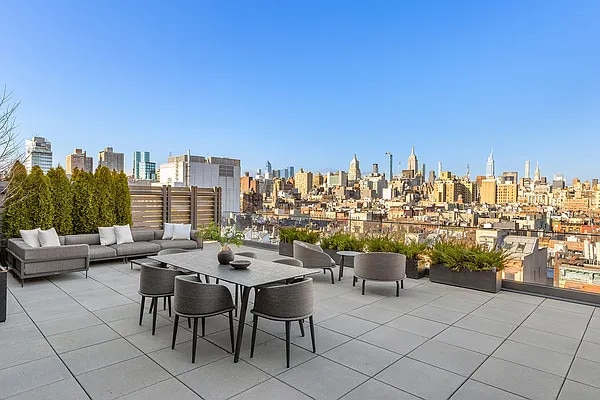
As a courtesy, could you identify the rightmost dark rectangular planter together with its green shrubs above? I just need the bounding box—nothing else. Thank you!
[429,242,506,293]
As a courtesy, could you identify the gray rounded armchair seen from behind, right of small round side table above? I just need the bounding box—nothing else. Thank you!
[352,252,406,297]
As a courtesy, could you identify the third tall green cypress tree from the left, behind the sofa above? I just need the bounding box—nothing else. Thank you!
[47,166,73,235]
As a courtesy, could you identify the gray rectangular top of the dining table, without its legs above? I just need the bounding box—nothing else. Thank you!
[149,249,319,287]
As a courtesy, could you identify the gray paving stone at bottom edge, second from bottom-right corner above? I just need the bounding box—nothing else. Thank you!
[472,357,564,400]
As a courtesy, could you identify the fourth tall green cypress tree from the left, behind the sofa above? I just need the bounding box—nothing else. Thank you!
[71,170,98,233]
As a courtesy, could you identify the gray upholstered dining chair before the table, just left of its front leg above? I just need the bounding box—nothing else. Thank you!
[171,275,235,363]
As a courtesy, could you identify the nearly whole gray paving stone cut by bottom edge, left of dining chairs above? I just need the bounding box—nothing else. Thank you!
[77,356,171,400]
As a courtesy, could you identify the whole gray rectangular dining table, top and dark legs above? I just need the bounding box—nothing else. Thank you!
[148,247,318,363]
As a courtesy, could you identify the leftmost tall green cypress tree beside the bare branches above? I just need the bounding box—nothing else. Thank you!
[2,161,32,238]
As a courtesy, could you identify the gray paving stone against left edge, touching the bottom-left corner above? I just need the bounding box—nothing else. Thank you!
[0,356,71,399]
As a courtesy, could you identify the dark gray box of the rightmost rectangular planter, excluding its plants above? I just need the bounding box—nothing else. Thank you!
[429,264,502,293]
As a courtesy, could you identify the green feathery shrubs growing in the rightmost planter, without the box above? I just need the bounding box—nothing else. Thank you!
[428,242,507,271]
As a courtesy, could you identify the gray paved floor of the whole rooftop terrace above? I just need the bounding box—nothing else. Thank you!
[0,244,600,400]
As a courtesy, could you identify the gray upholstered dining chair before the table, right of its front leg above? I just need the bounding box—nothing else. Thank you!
[250,278,316,368]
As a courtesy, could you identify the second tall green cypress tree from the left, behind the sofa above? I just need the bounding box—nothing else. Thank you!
[23,165,54,229]
